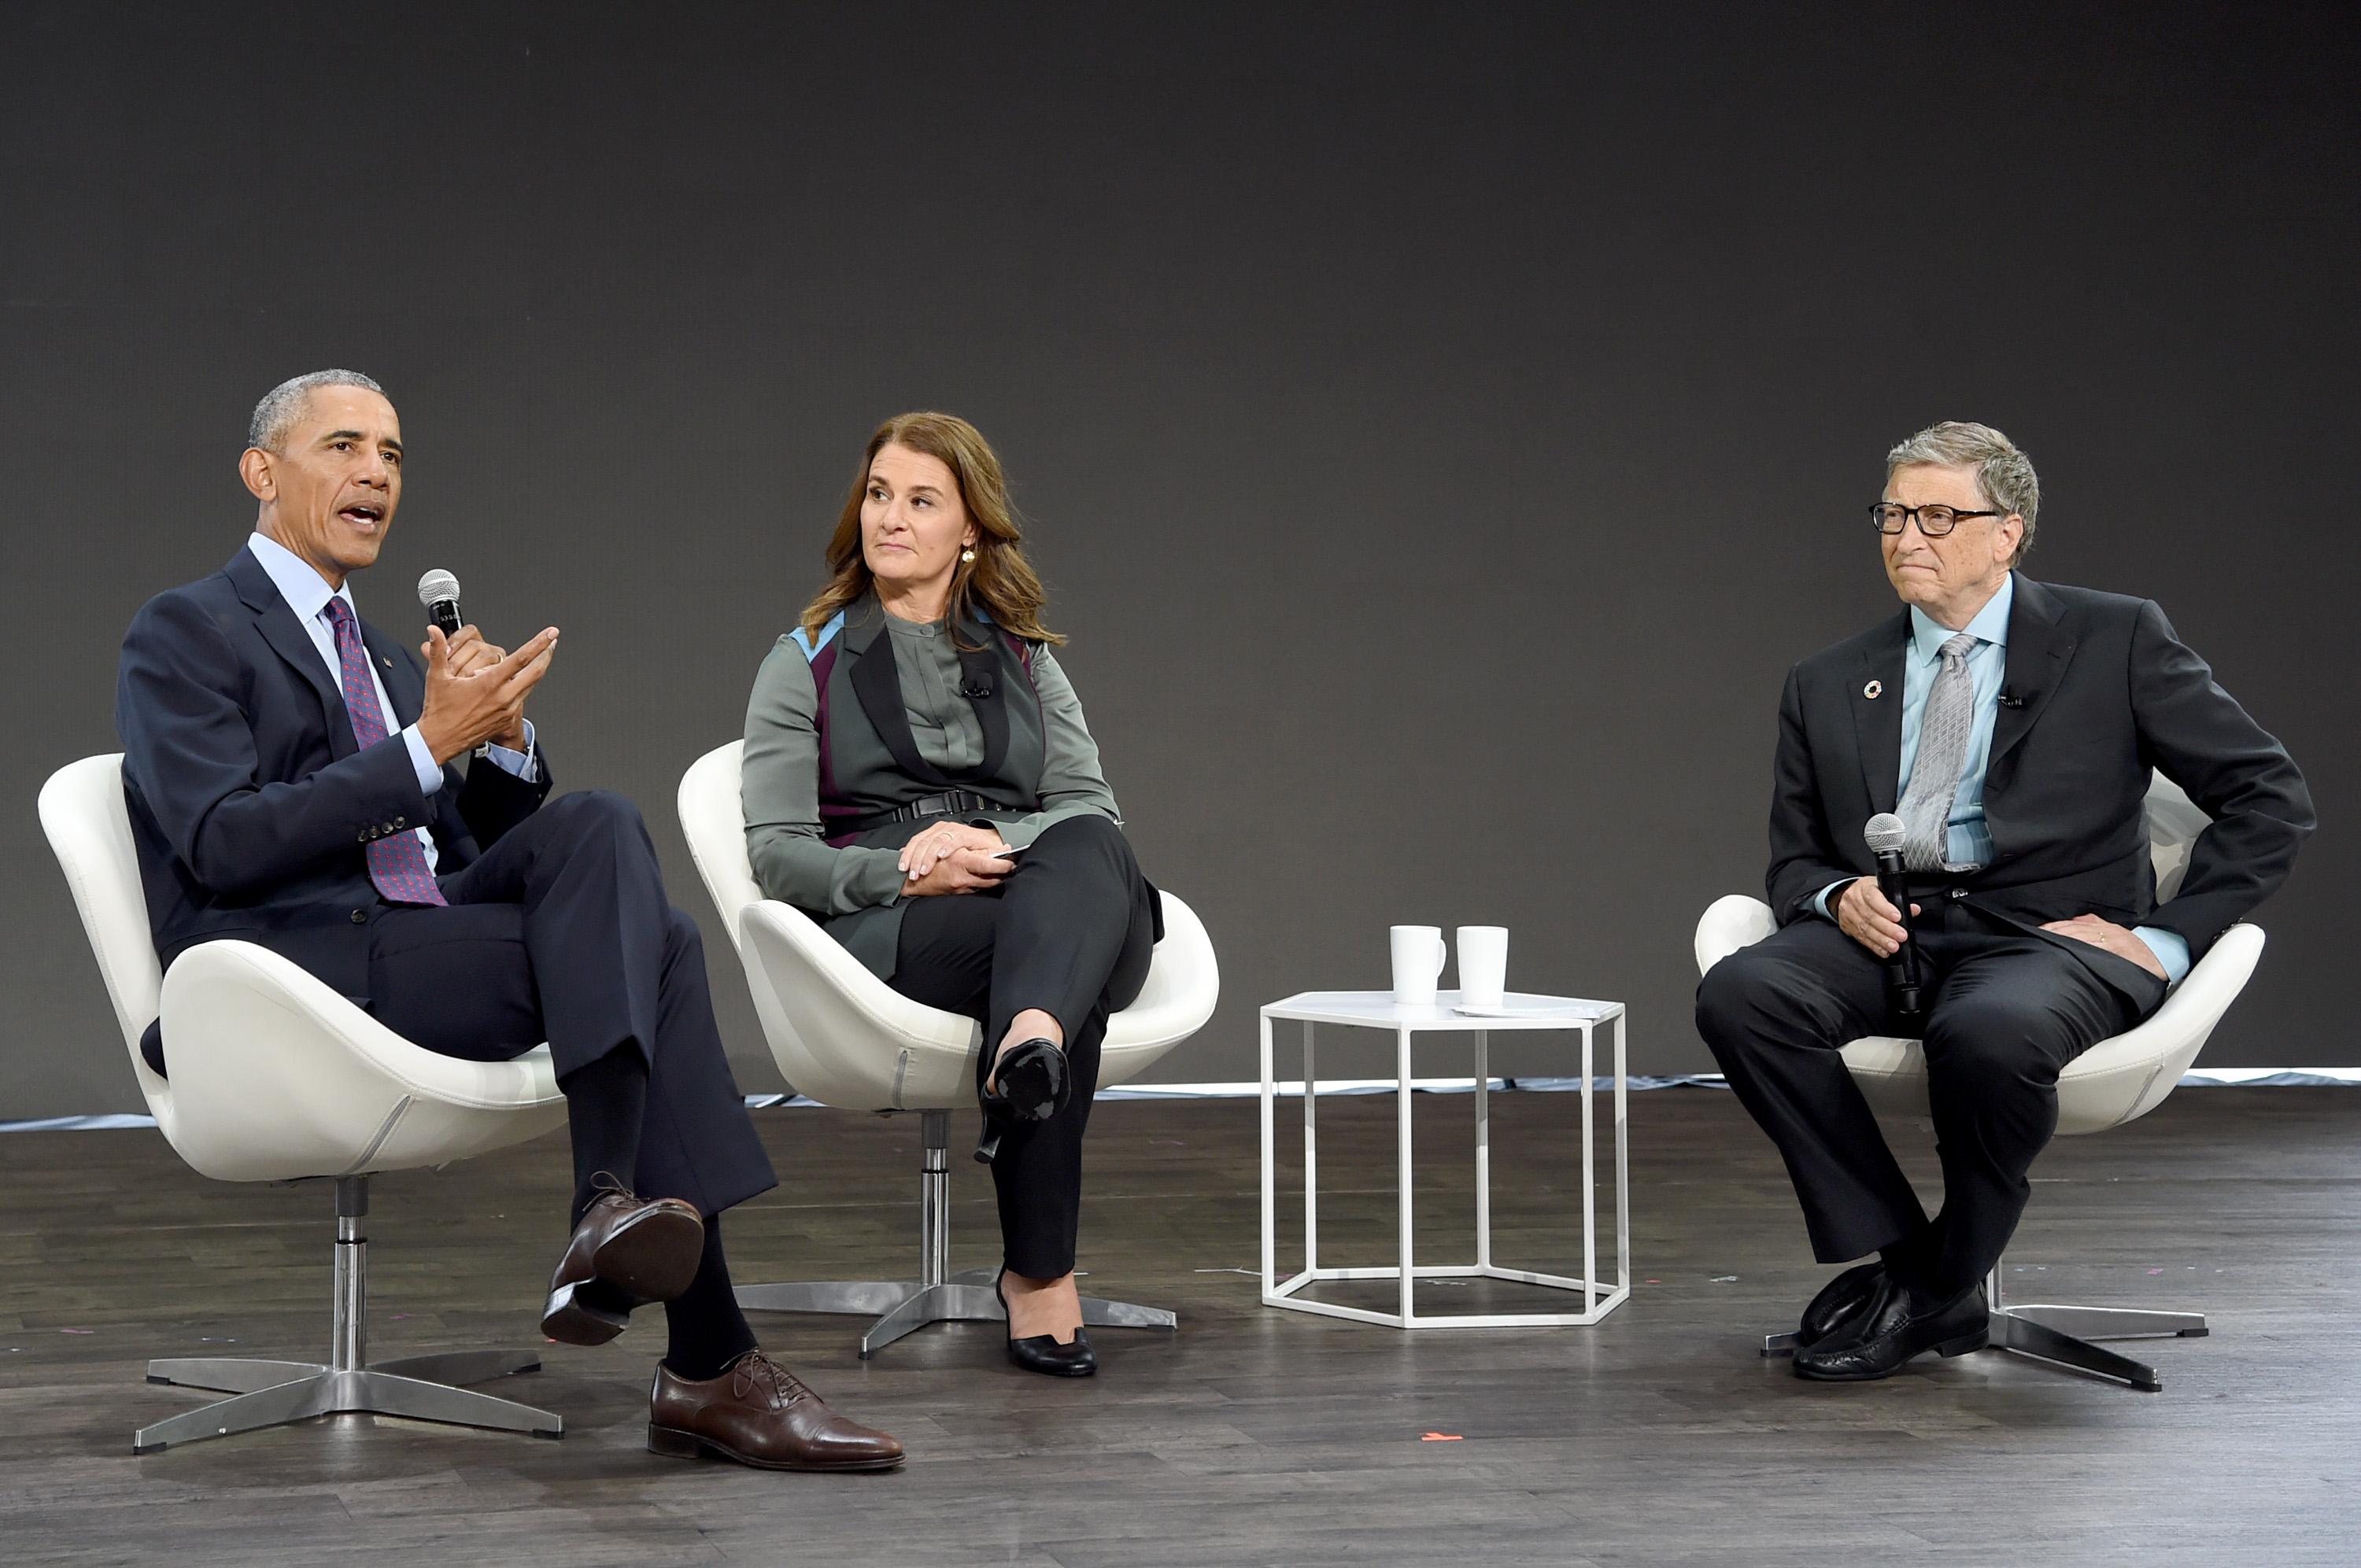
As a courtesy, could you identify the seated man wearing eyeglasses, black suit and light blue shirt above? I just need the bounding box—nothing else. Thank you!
[1698,422,2311,1382]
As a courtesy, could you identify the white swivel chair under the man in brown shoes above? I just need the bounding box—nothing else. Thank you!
[40,755,567,1452]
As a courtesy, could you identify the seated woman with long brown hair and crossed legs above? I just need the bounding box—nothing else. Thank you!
[744,413,1162,1377]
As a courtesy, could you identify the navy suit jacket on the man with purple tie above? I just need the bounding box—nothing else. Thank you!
[116,550,550,1004]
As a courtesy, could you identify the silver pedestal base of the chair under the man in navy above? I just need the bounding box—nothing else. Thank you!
[132,1176,564,1455]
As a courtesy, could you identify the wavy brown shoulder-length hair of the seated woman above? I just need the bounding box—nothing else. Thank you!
[800,413,1065,642]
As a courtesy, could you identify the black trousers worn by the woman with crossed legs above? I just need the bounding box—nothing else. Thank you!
[892,817,1155,1280]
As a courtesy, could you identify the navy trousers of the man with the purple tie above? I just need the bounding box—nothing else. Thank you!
[368,791,779,1214]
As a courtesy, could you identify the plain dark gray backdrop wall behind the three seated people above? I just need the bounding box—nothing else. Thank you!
[0,2,2361,1117]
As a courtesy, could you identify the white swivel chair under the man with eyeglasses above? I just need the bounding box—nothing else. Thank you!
[1698,774,2262,1393]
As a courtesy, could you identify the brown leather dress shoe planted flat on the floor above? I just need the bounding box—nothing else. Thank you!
[647,1351,902,1471]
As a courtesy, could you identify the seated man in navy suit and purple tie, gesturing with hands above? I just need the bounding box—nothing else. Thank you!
[116,371,902,1469]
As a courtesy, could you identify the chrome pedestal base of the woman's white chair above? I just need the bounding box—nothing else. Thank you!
[737,1110,1180,1360]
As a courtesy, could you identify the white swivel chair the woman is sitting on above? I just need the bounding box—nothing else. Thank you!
[680,741,1221,1358]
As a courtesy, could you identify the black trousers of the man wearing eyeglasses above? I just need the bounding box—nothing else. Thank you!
[1698,900,2165,1299]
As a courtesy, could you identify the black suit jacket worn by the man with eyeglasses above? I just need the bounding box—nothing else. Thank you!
[1768,574,2314,959]
